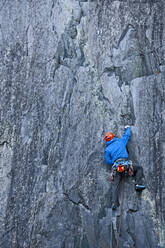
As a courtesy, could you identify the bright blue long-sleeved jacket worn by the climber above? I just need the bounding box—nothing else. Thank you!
[105,127,131,165]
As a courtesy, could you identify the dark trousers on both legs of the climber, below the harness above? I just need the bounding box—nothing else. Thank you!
[112,165,143,206]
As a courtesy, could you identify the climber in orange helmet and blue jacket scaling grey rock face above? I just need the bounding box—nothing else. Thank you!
[105,126,145,210]
